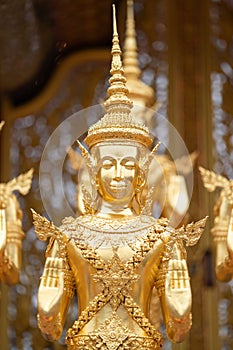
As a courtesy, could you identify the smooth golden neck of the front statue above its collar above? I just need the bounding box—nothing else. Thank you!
[97,201,136,219]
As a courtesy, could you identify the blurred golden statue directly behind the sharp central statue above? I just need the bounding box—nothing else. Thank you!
[68,0,197,227]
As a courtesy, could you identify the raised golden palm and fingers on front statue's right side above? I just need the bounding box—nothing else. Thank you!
[165,259,192,319]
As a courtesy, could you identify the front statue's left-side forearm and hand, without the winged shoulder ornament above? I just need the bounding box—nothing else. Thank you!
[38,241,74,341]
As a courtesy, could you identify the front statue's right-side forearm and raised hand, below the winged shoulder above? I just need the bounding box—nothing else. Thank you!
[159,244,192,342]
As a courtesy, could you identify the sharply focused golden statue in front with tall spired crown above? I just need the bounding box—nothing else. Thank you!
[33,7,206,350]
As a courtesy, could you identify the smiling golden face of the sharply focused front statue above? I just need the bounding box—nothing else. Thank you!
[97,144,139,205]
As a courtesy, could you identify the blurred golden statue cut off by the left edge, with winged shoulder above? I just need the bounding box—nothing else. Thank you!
[0,123,33,285]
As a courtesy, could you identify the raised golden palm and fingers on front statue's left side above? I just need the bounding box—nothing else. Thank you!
[38,258,64,319]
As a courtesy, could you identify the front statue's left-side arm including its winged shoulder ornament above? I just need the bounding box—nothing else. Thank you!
[32,210,75,341]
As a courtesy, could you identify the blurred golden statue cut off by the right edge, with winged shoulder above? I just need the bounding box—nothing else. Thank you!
[199,167,233,282]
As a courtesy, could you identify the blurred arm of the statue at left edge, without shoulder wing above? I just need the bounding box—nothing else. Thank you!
[0,194,24,285]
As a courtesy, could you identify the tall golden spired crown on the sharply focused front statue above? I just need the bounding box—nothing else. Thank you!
[85,5,153,148]
